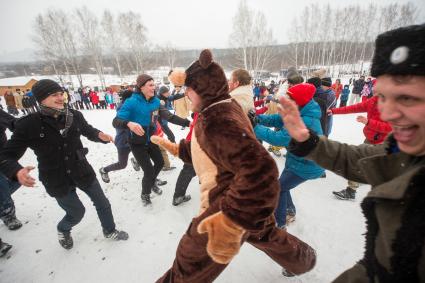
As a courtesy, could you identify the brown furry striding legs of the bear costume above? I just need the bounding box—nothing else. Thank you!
[157,199,316,283]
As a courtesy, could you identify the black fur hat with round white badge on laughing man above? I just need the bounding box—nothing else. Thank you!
[371,24,425,77]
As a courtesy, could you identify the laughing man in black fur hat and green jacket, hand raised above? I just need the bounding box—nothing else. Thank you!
[279,24,425,283]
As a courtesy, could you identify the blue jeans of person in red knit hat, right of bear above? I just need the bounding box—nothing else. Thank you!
[275,169,307,227]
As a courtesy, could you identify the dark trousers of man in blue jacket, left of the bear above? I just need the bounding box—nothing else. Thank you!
[130,143,164,194]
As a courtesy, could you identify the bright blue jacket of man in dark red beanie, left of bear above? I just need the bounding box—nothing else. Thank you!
[117,92,160,143]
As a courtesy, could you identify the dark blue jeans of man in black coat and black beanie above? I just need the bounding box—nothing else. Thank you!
[56,179,115,233]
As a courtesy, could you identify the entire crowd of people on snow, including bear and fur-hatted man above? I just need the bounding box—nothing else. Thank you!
[0,22,425,282]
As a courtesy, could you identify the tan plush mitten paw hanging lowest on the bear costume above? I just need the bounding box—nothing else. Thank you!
[198,211,245,264]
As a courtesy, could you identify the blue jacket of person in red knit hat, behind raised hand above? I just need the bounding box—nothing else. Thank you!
[254,100,324,179]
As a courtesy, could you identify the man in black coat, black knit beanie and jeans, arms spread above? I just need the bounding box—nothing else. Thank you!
[0,79,128,249]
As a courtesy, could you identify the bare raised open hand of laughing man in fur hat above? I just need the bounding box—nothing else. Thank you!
[277,96,310,142]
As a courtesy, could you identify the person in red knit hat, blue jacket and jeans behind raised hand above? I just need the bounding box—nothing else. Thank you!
[251,83,324,228]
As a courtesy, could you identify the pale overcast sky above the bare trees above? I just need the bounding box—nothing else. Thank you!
[0,0,425,54]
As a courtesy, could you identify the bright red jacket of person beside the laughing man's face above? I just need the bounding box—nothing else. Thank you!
[331,96,392,144]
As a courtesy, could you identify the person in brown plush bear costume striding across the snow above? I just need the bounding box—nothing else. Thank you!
[152,50,316,283]
